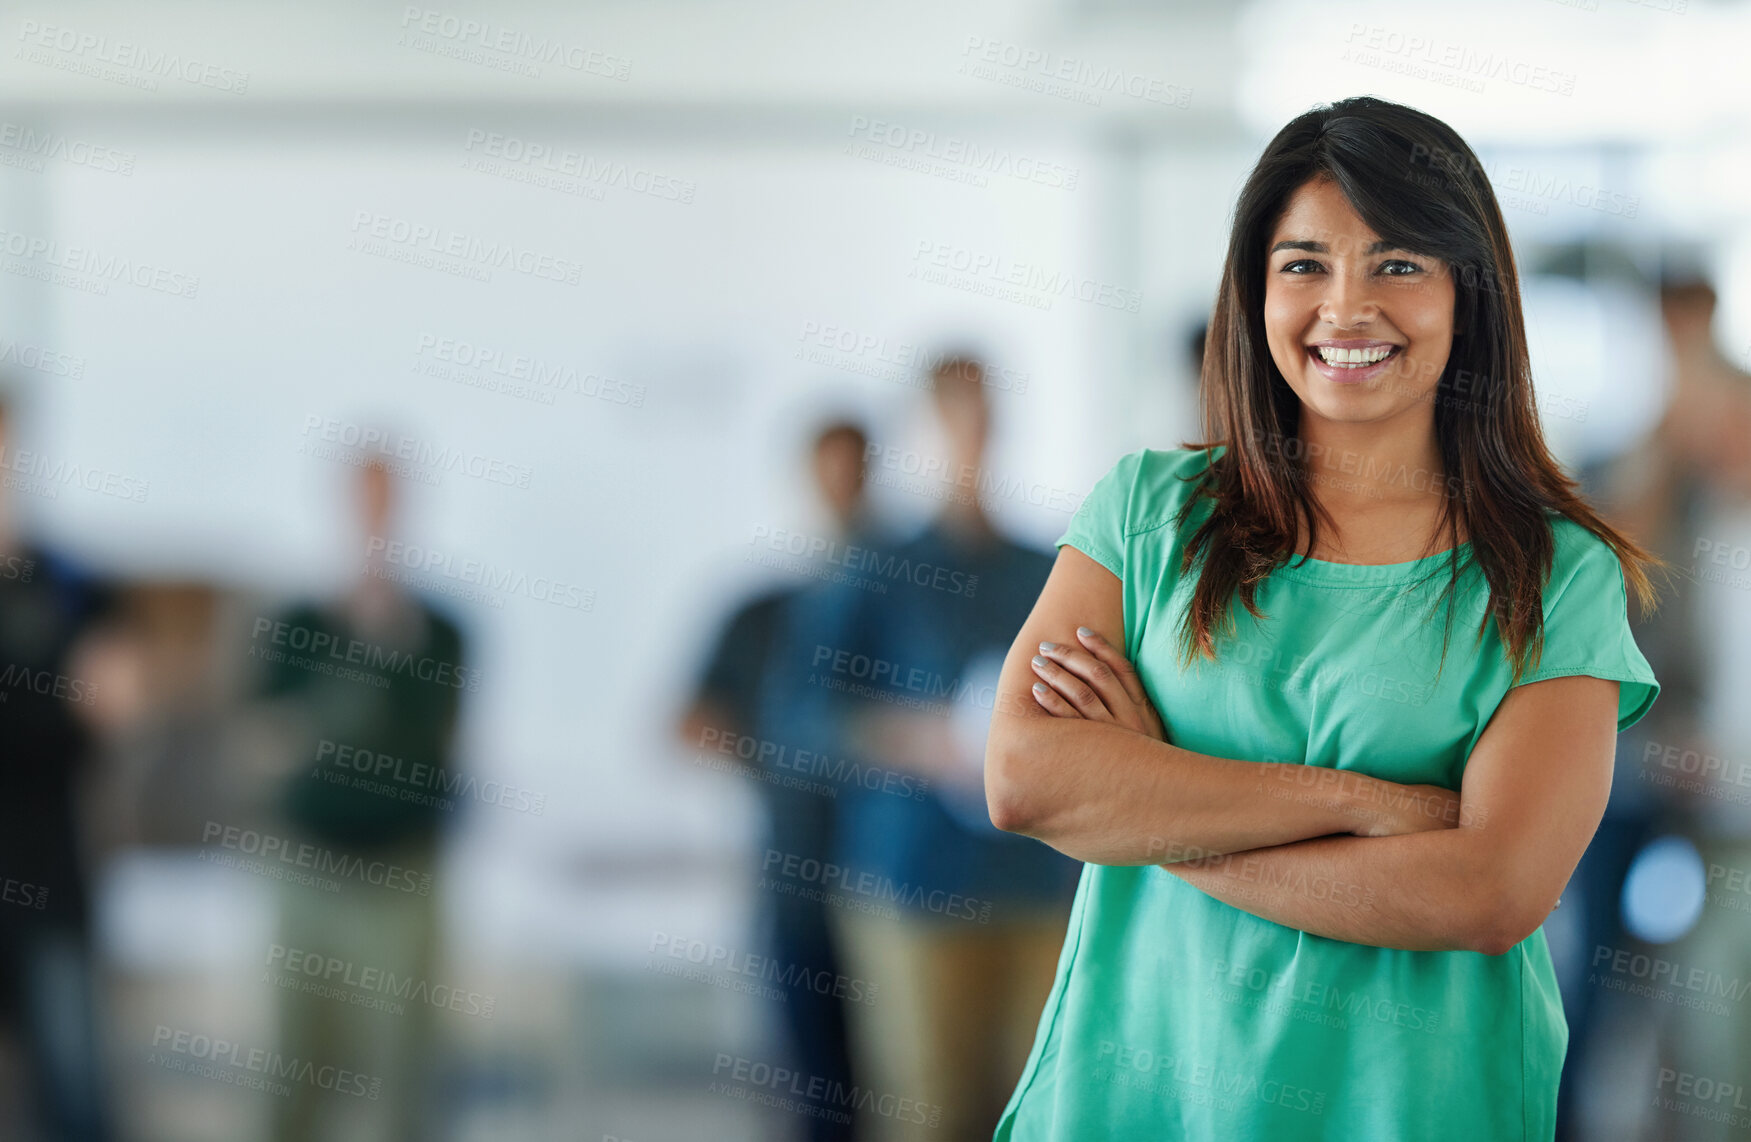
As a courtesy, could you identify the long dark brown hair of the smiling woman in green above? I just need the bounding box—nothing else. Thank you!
[1180,96,1665,683]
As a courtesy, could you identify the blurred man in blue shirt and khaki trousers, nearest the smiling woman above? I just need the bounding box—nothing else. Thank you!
[776,356,1079,1138]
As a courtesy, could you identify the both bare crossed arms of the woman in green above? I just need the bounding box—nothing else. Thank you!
[986,546,1618,955]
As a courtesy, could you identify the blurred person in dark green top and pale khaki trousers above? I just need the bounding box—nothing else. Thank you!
[250,461,475,1142]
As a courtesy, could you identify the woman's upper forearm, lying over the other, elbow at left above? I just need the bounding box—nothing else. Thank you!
[986,713,1439,865]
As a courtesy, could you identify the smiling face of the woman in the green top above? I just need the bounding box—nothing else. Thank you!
[1264,177,1453,424]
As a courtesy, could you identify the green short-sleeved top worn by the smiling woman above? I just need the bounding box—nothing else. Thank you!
[996,448,1660,1142]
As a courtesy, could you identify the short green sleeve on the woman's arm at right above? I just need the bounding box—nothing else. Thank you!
[1522,520,1660,734]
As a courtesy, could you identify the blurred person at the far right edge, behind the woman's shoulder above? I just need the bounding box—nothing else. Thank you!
[1637,280,1751,1138]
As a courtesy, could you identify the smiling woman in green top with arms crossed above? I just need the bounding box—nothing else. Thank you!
[986,98,1658,1142]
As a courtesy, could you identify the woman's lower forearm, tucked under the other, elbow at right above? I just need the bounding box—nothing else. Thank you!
[1166,828,1505,955]
